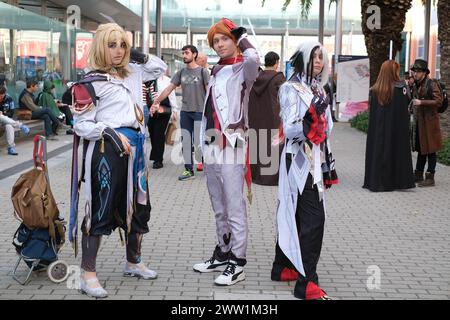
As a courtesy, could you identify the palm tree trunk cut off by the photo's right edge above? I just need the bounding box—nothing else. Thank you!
[437,0,450,137]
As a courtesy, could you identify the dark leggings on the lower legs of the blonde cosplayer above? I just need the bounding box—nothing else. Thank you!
[81,232,142,272]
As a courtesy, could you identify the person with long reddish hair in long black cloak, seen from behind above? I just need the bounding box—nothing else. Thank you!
[363,60,415,192]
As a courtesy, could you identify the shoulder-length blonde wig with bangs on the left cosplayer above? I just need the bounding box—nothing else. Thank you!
[88,23,131,78]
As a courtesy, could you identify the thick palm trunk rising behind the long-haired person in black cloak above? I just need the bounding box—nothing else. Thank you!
[361,0,412,86]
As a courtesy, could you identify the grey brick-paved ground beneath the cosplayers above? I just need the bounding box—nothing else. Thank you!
[0,123,450,300]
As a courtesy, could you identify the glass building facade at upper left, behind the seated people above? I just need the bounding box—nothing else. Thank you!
[0,2,93,99]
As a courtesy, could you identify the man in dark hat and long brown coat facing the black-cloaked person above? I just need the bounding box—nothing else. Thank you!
[411,59,443,187]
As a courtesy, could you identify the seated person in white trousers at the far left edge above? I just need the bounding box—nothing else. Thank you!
[0,87,30,156]
